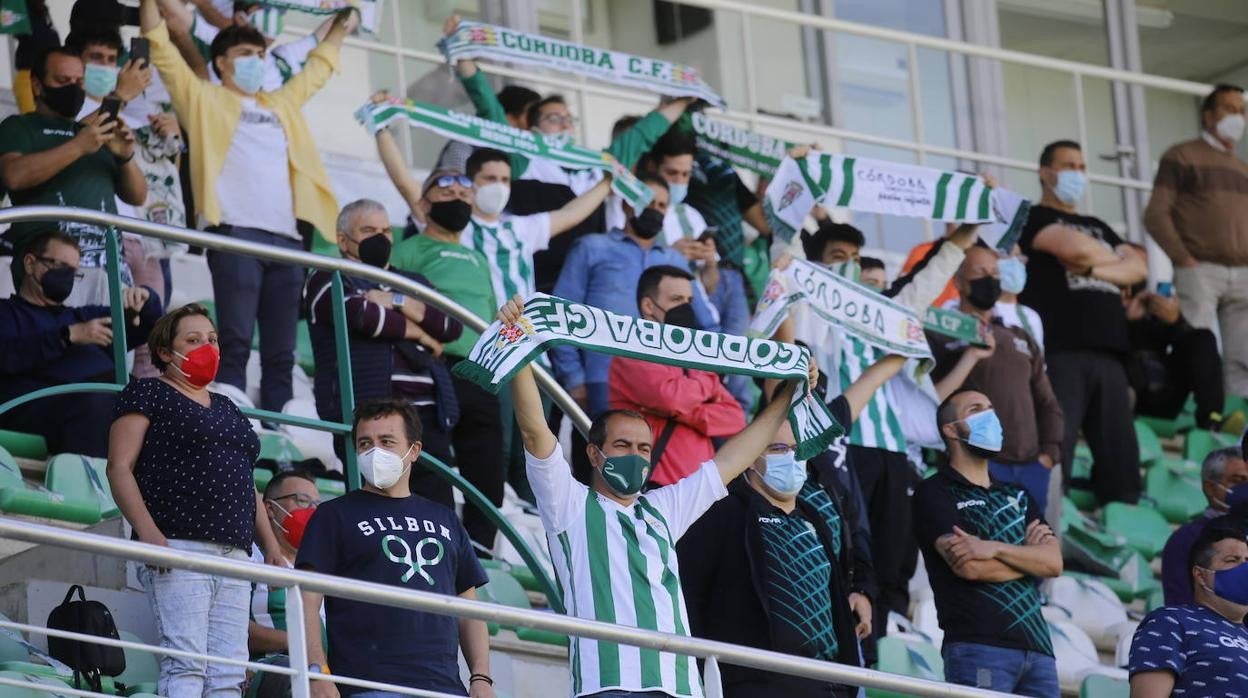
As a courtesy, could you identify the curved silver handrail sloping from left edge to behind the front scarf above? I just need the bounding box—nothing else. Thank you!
[0,206,589,433]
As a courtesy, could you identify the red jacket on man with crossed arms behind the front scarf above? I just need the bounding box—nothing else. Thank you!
[608,357,745,484]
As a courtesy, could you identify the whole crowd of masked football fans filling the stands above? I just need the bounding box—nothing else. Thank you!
[0,0,1248,697]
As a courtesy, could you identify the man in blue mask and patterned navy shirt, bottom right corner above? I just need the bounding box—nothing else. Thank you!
[1127,517,1248,698]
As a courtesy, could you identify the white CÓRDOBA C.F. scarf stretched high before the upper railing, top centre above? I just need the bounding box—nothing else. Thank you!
[438,21,725,106]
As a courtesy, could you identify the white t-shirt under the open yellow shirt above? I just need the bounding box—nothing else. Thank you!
[216,97,300,240]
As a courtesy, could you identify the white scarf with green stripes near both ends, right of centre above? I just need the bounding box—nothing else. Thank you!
[764,151,1028,250]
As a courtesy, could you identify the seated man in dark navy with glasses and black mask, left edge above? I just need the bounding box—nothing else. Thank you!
[0,227,160,458]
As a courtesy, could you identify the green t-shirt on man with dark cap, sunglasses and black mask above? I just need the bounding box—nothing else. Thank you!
[391,235,498,358]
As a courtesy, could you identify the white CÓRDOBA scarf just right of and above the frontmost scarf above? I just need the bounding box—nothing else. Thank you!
[749,260,931,358]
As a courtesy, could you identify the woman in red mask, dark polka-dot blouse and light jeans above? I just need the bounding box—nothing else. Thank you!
[107,303,280,697]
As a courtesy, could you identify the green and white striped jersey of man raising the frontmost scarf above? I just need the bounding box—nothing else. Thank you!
[525,446,728,697]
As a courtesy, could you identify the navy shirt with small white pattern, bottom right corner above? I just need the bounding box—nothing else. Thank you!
[1127,604,1248,698]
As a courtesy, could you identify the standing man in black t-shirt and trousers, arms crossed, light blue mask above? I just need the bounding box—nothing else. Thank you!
[1018,140,1148,503]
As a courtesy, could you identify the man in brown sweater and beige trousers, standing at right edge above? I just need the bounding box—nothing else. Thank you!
[1144,85,1248,396]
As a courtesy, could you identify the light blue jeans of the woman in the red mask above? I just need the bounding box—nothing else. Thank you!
[139,539,251,698]
